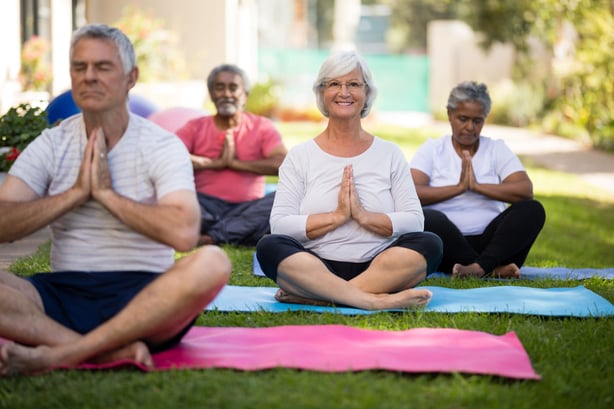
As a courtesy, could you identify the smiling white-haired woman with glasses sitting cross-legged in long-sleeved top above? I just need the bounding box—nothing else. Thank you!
[256,52,442,310]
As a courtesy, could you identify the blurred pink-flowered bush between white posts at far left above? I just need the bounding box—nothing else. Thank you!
[19,36,52,91]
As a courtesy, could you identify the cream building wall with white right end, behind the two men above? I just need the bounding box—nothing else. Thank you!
[86,0,258,108]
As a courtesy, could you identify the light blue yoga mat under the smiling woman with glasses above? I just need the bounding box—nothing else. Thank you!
[206,285,614,317]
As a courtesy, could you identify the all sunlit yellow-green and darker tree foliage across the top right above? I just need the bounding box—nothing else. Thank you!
[380,0,614,149]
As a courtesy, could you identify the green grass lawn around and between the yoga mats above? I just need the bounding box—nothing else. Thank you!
[0,124,614,409]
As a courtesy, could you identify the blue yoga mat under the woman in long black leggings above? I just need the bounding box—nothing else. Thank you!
[253,252,614,280]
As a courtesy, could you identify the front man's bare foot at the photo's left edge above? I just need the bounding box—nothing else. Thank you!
[0,342,54,376]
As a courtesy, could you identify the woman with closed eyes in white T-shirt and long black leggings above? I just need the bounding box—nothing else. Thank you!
[411,81,546,278]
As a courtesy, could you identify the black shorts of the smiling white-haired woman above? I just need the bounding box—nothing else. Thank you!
[256,232,443,282]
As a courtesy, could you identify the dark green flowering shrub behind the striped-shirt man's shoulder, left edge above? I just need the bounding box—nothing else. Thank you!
[0,103,49,172]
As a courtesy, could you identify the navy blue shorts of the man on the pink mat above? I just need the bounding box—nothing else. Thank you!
[26,271,195,352]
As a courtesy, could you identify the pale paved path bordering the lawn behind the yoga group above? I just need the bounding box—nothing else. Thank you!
[0,118,614,271]
